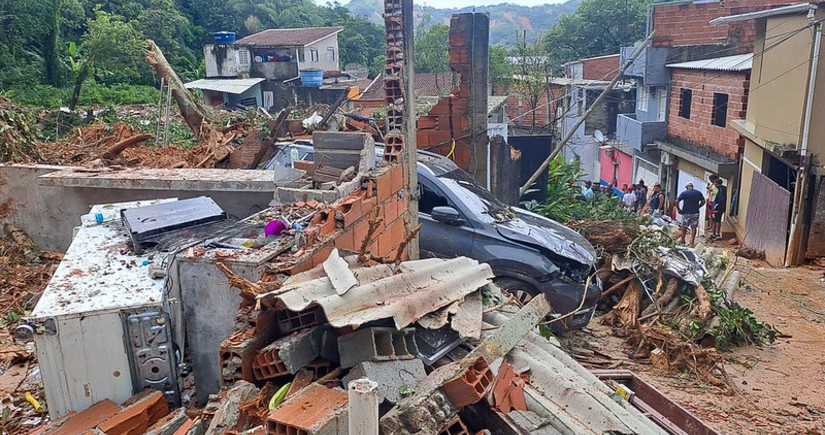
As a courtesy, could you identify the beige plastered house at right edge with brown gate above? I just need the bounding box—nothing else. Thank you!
[714,3,825,266]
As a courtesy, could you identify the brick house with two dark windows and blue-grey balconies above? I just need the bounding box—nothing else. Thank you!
[616,0,788,212]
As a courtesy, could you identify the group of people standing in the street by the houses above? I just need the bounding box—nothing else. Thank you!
[583,175,728,244]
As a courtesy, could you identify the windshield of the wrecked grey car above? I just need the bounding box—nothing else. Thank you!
[438,169,515,223]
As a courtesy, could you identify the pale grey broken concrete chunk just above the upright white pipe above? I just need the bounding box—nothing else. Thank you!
[342,359,427,403]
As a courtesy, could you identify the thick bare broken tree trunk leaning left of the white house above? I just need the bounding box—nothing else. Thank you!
[146,39,212,140]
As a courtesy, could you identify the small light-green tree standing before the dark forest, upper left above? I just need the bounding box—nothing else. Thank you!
[69,9,145,110]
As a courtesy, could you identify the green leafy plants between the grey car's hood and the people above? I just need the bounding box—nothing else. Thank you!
[531,156,639,223]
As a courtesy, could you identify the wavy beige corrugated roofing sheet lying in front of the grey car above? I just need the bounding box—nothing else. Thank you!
[258,257,493,329]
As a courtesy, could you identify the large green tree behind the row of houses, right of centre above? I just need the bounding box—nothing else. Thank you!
[544,0,654,63]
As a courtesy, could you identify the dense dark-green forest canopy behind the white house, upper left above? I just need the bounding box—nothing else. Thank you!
[0,0,385,94]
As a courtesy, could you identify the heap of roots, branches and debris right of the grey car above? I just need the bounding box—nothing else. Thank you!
[598,226,778,389]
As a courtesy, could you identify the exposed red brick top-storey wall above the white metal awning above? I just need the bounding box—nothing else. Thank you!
[653,0,794,49]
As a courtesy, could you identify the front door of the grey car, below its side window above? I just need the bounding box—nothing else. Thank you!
[418,177,475,258]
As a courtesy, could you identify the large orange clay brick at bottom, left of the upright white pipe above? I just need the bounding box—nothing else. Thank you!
[266,385,348,435]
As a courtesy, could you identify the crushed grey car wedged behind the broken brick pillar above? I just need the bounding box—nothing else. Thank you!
[267,145,601,332]
